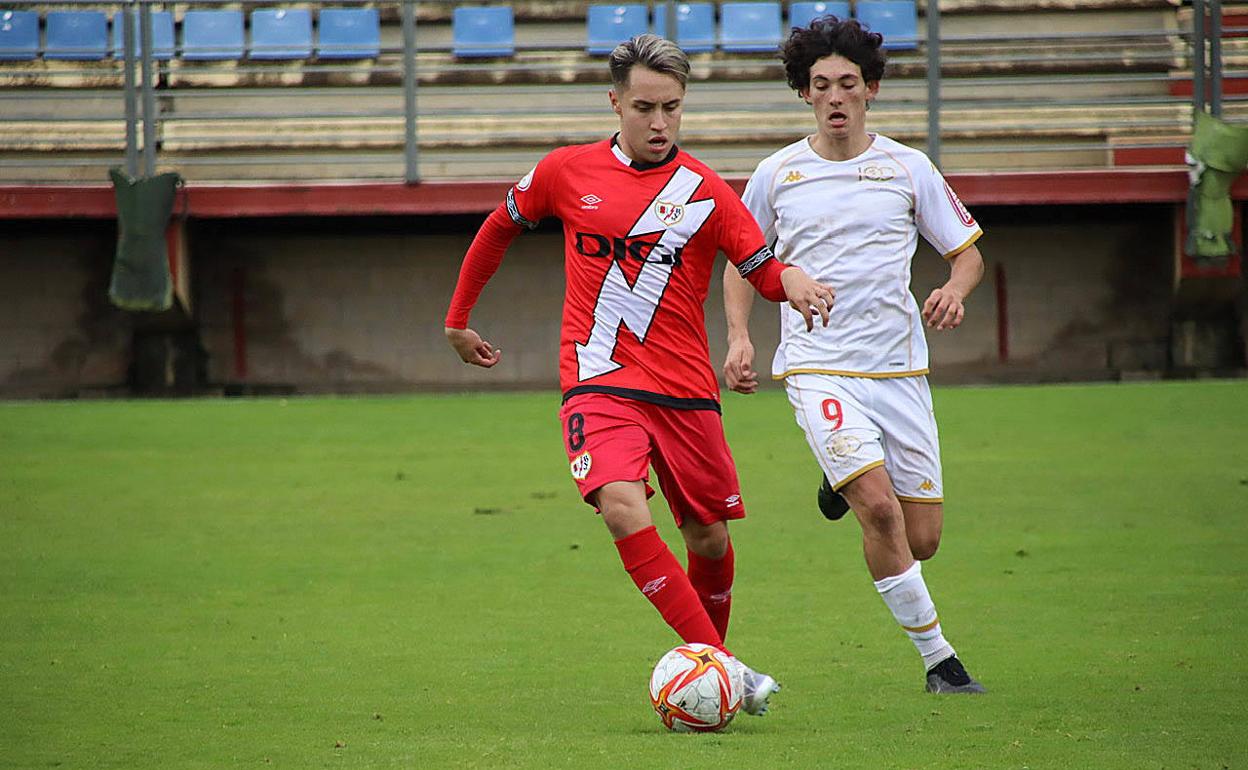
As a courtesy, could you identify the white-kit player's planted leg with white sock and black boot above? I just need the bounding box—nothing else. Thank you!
[841,467,985,693]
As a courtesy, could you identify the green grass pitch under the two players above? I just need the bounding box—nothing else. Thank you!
[0,381,1248,770]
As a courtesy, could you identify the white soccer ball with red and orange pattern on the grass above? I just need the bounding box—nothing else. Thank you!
[650,643,745,733]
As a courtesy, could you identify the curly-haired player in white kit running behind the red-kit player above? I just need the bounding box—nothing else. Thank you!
[724,16,985,693]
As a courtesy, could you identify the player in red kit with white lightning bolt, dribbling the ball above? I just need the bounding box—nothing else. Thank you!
[446,35,832,714]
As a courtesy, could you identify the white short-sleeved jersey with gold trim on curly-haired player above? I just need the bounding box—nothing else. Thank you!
[743,134,983,379]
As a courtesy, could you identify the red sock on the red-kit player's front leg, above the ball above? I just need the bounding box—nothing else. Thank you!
[615,527,731,648]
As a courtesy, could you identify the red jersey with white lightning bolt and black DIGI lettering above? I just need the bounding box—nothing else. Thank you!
[447,140,784,411]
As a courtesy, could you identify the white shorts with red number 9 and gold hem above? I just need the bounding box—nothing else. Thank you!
[785,374,943,503]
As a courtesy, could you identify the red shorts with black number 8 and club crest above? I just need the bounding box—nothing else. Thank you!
[559,393,745,527]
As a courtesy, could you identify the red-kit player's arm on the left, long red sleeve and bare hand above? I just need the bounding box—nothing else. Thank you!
[443,155,554,369]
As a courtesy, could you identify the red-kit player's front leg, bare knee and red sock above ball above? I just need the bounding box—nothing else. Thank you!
[592,482,724,648]
